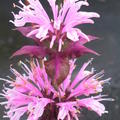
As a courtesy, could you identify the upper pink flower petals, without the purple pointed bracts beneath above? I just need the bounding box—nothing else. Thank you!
[11,0,100,52]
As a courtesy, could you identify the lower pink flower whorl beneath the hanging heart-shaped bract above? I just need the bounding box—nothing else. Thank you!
[0,60,112,120]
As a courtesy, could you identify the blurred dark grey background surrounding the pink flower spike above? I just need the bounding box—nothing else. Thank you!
[0,0,120,120]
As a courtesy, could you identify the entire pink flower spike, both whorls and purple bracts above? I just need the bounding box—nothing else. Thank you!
[0,0,112,120]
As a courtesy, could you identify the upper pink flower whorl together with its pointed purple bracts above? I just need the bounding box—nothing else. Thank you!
[10,0,100,57]
